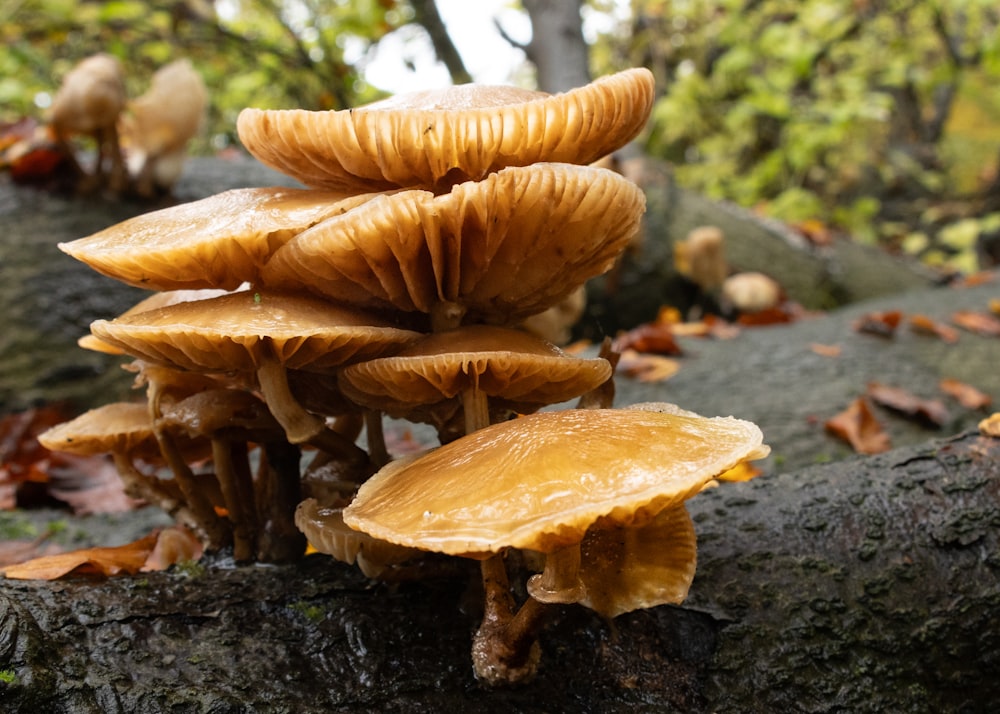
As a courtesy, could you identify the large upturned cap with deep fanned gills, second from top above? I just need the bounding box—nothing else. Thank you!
[261,163,645,323]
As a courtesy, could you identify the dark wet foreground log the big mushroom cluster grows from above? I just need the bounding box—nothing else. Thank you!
[0,433,1000,714]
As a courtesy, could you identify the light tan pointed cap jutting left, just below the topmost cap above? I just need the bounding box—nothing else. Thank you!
[59,187,384,290]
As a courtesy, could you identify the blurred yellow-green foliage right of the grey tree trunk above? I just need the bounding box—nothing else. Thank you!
[593,0,1000,268]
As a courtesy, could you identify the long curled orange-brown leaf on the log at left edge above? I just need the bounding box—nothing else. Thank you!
[3,526,201,580]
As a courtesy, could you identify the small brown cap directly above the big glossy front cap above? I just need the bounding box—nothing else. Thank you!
[339,325,611,416]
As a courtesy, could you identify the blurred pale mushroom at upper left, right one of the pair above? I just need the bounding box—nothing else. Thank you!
[122,59,208,196]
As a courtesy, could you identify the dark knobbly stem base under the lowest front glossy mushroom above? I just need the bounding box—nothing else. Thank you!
[472,555,547,685]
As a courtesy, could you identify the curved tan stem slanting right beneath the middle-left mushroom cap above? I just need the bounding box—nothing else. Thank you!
[257,356,365,460]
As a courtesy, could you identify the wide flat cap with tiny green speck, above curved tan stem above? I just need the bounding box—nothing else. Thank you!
[81,291,419,372]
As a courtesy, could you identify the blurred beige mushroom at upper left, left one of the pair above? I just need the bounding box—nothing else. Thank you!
[49,53,126,191]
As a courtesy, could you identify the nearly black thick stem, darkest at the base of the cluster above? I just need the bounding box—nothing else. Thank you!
[257,441,306,563]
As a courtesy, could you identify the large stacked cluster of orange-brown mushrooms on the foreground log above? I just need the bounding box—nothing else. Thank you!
[42,69,767,683]
